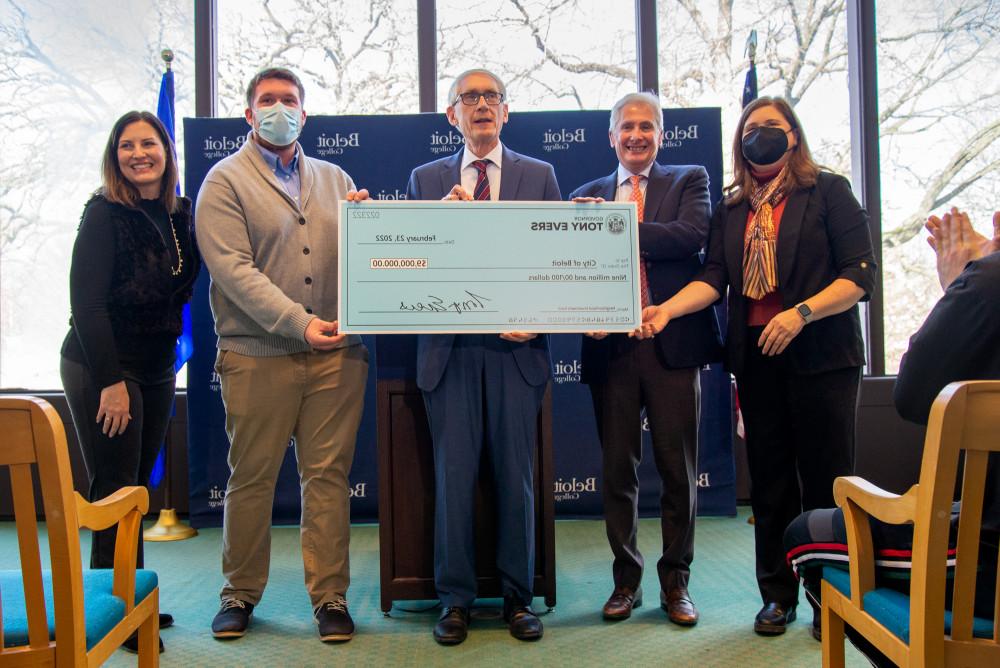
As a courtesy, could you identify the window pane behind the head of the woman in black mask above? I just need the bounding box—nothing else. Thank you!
[657,0,851,184]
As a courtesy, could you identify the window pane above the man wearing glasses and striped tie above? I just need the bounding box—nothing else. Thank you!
[437,0,636,111]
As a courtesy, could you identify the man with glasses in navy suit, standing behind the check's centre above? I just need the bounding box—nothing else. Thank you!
[406,69,561,645]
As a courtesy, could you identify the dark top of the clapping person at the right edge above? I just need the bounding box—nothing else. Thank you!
[893,252,1000,531]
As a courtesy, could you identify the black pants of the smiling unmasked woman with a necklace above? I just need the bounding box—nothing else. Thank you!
[59,357,176,568]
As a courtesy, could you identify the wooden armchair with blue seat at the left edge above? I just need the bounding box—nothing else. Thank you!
[0,396,159,667]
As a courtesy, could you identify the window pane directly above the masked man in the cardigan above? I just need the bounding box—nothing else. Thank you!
[218,0,419,116]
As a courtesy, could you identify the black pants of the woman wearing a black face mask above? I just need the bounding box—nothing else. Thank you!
[736,328,861,607]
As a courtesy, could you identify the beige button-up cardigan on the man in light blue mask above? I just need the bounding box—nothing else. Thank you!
[195,137,360,357]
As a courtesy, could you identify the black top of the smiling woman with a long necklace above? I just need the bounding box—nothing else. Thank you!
[62,195,200,388]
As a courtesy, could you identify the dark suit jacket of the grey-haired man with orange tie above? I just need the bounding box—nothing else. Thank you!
[570,162,722,383]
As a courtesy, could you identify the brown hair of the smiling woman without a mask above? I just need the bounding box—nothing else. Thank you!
[98,111,178,213]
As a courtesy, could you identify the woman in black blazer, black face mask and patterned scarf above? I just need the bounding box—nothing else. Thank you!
[635,97,876,635]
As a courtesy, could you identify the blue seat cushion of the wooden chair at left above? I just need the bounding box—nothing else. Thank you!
[0,568,157,649]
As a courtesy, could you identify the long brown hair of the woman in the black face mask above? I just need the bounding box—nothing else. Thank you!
[725,96,820,206]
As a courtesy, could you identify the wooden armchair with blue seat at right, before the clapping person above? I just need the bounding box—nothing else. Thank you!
[822,381,1000,668]
